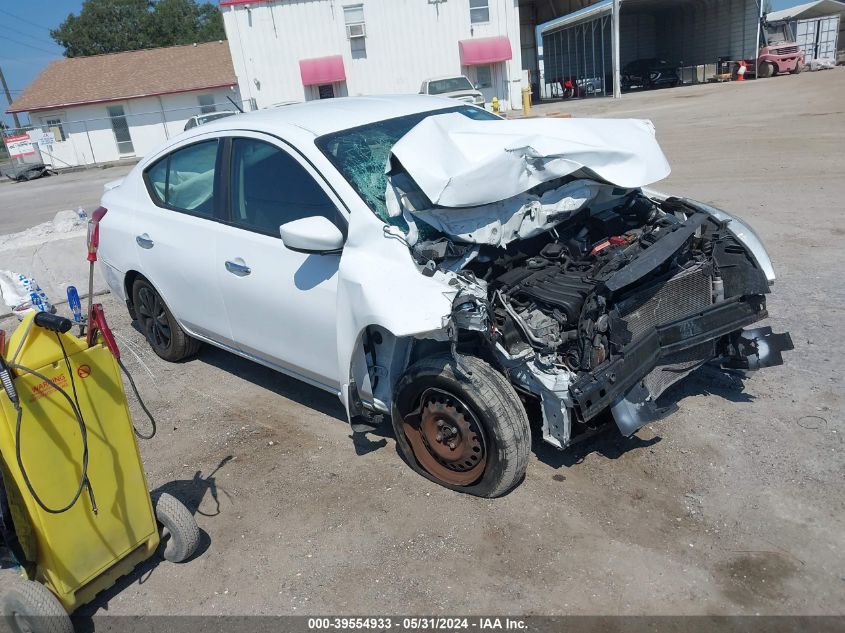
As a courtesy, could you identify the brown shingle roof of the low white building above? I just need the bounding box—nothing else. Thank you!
[6,41,237,113]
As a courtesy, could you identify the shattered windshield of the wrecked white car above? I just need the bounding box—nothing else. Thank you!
[316,106,499,222]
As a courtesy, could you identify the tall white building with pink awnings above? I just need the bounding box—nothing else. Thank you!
[220,0,523,109]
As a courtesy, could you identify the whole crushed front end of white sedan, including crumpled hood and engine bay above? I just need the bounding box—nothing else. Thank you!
[366,114,792,448]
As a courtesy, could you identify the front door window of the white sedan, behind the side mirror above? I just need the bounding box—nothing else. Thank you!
[231,138,338,237]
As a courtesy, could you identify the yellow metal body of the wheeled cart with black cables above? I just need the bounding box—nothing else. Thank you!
[0,314,159,612]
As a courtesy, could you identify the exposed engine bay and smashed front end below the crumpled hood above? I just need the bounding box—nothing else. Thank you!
[390,180,791,448]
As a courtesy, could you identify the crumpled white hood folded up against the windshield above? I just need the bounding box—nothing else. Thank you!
[391,113,670,207]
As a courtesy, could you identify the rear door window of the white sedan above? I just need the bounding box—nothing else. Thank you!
[144,139,217,218]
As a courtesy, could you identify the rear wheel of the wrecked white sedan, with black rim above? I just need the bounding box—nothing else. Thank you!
[132,277,202,363]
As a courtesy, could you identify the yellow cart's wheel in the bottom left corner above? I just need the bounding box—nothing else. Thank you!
[0,579,73,633]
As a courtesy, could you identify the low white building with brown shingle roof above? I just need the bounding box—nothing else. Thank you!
[7,42,240,168]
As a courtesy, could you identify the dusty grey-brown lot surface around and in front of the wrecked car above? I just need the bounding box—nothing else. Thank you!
[0,69,845,614]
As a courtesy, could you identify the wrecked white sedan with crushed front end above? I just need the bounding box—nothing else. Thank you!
[94,96,792,497]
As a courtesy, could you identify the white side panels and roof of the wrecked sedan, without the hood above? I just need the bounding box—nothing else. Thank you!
[99,95,468,404]
